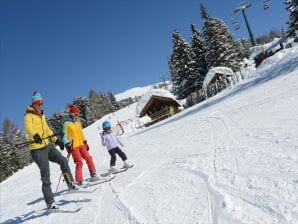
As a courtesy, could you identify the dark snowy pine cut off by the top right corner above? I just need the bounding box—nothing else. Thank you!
[284,0,298,42]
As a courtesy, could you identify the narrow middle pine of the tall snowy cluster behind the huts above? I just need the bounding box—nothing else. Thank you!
[191,24,208,89]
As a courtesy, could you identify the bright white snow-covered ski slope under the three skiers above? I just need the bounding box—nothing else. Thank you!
[0,45,298,224]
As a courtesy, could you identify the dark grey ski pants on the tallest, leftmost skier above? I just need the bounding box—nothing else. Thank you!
[31,144,73,204]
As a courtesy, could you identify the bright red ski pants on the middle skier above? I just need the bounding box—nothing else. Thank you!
[72,145,96,182]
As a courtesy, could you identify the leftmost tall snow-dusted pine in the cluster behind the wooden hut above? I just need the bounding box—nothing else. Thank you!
[169,31,199,99]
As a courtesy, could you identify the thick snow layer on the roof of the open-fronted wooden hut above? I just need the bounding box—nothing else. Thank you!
[136,89,180,115]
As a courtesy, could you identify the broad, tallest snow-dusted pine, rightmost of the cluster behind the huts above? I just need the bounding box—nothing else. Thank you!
[201,5,242,71]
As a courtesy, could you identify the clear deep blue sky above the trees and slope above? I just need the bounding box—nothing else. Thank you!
[0,0,288,128]
